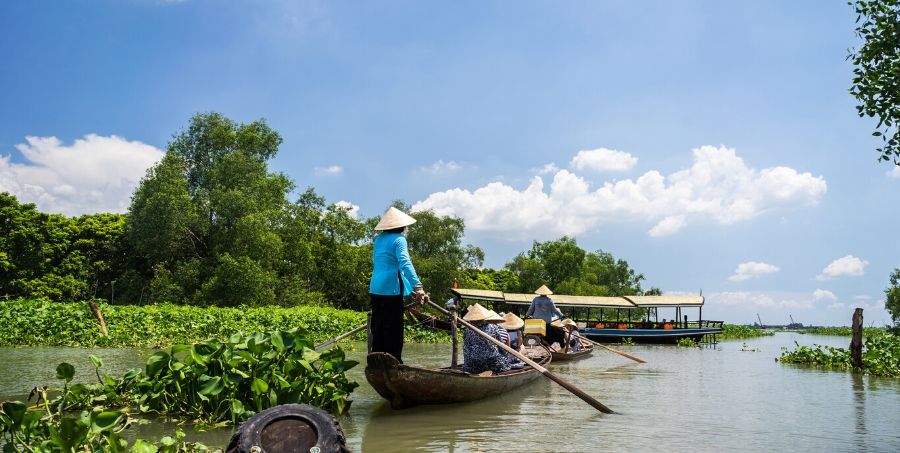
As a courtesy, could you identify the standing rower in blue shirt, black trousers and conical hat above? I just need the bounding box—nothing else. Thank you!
[369,206,425,363]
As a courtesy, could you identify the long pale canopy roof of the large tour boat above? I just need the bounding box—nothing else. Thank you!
[450,288,704,308]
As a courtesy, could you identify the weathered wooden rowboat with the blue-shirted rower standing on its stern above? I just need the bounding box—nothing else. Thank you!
[366,346,551,409]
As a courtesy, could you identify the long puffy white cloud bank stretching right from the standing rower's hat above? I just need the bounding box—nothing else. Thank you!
[413,146,826,237]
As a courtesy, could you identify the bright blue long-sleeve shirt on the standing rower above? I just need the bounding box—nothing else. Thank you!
[369,233,422,297]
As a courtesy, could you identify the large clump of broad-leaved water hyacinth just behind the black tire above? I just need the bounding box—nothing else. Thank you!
[58,329,357,426]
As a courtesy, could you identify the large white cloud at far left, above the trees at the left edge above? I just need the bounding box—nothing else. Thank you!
[0,134,164,215]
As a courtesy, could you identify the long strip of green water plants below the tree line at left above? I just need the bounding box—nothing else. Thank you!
[0,299,449,348]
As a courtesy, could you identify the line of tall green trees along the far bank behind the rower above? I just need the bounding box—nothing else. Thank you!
[0,113,659,309]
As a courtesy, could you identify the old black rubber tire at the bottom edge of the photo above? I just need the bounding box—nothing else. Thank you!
[225,404,349,453]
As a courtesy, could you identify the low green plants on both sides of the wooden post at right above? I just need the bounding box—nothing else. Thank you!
[779,331,900,376]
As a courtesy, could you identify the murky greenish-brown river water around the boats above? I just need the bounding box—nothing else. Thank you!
[0,333,900,452]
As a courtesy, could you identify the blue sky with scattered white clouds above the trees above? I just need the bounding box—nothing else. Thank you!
[0,0,900,326]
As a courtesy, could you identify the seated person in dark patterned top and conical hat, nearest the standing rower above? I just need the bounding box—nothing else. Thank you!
[463,304,510,374]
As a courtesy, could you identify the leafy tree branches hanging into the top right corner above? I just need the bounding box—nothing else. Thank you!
[848,0,900,165]
